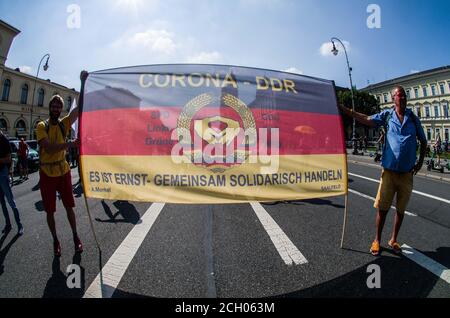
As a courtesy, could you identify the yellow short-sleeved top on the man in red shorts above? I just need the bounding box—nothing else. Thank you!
[36,116,70,177]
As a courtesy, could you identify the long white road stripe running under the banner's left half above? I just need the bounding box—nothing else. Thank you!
[83,203,164,298]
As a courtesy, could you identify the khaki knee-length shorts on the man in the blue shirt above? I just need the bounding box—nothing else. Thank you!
[373,169,413,214]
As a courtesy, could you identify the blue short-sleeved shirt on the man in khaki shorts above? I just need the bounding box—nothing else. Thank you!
[369,108,427,172]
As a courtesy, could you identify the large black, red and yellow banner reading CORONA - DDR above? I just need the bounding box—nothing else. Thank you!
[80,65,347,203]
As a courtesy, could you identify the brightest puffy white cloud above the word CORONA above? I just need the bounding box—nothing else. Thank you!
[112,29,177,55]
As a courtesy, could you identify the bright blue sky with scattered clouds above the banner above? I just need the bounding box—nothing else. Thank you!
[0,0,450,90]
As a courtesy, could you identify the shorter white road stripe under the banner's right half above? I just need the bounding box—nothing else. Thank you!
[250,202,308,265]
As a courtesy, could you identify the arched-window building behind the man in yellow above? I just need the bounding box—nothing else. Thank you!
[0,20,79,139]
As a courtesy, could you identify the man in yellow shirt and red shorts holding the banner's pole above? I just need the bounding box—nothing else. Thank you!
[37,95,83,256]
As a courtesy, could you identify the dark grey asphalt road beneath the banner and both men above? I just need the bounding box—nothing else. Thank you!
[0,156,450,298]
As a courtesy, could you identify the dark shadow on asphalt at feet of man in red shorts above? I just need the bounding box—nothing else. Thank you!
[42,253,85,298]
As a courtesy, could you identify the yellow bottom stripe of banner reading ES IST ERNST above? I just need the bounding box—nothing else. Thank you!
[81,154,348,204]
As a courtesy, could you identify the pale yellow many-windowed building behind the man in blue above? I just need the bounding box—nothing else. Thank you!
[362,66,450,143]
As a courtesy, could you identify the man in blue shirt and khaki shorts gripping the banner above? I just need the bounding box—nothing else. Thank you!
[339,86,427,256]
